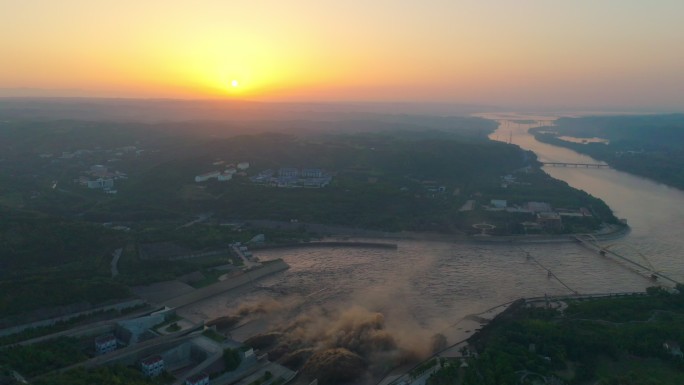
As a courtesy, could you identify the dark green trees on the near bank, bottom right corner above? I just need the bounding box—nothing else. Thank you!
[429,288,684,385]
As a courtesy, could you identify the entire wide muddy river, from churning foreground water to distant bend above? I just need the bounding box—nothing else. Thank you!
[184,115,684,348]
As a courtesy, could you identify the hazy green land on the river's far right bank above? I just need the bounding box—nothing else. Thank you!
[532,114,684,189]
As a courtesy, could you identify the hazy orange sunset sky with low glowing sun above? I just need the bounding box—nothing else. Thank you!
[0,0,684,111]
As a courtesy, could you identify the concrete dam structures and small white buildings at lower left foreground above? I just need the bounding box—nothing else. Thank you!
[83,307,296,385]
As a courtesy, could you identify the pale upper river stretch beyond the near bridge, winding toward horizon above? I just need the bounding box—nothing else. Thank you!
[487,115,684,282]
